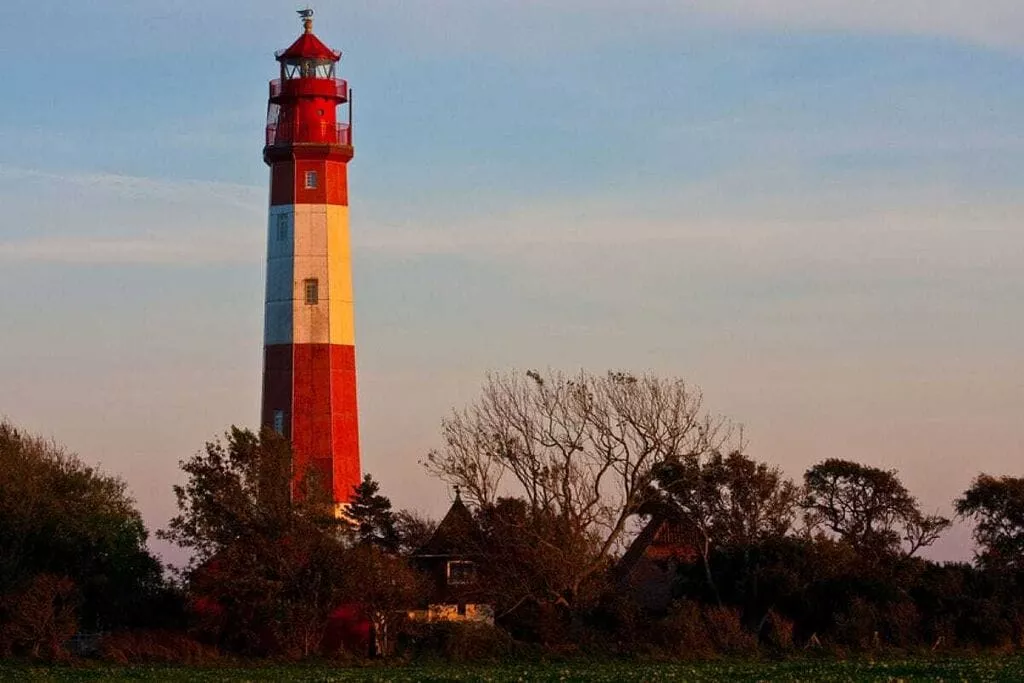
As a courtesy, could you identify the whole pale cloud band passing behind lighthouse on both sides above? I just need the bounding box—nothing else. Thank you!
[0,161,1024,271]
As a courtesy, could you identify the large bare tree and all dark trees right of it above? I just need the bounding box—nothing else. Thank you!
[417,372,1024,656]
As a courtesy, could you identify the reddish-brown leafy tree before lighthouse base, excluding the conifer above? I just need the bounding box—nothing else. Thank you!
[160,427,349,655]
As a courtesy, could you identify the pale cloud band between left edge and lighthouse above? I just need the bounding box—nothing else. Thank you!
[0,166,265,264]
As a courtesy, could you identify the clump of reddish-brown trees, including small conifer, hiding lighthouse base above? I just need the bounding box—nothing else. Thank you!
[161,427,421,656]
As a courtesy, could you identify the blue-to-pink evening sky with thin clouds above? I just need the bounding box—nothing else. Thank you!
[0,0,1024,559]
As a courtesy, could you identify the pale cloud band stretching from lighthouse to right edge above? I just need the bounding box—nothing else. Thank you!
[353,180,1024,273]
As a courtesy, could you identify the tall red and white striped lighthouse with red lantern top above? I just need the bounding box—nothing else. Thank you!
[262,9,360,513]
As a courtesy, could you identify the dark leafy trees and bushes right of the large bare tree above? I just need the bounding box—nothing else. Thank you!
[612,454,1024,652]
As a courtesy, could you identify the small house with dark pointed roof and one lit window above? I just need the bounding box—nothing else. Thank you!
[409,488,495,624]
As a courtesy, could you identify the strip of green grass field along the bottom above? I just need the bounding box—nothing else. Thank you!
[0,656,1024,683]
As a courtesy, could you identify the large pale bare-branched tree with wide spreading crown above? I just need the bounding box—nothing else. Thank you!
[424,371,735,594]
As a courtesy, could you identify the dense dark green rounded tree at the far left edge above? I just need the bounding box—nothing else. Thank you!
[0,422,166,647]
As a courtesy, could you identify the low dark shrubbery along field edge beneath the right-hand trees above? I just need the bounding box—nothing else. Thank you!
[573,559,1024,658]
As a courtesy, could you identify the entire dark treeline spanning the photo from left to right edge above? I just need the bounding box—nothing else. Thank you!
[0,372,1024,661]
